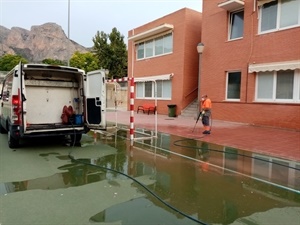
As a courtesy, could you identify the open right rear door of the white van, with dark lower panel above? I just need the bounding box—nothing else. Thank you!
[84,69,106,130]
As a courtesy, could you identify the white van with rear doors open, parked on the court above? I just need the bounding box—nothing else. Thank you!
[0,63,106,148]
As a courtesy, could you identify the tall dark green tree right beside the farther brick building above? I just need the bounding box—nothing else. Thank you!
[93,28,127,78]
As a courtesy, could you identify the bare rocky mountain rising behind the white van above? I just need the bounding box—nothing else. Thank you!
[0,23,89,62]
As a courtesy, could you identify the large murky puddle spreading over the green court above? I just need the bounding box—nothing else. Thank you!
[0,130,300,225]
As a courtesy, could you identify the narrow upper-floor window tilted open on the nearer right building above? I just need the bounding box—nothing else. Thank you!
[229,11,244,40]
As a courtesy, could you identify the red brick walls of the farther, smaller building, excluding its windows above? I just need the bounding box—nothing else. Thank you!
[128,8,202,115]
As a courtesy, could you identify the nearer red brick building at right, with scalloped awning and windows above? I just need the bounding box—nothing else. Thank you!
[200,0,300,130]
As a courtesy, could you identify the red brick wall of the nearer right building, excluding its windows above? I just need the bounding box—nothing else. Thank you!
[200,0,300,130]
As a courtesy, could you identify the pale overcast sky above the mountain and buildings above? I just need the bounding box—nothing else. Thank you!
[0,0,202,47]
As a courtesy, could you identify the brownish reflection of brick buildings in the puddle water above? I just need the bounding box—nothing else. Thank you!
[97,131,300,224]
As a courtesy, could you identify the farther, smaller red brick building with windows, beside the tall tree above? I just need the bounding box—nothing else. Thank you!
[128,8,202,115]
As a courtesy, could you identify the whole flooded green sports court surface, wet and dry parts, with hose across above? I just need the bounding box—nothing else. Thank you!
[0,129,300,225]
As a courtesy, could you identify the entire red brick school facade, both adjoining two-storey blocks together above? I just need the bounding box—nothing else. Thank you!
[128,0,300,131]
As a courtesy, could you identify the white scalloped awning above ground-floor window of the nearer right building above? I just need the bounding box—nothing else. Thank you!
[248,60,300,73]
